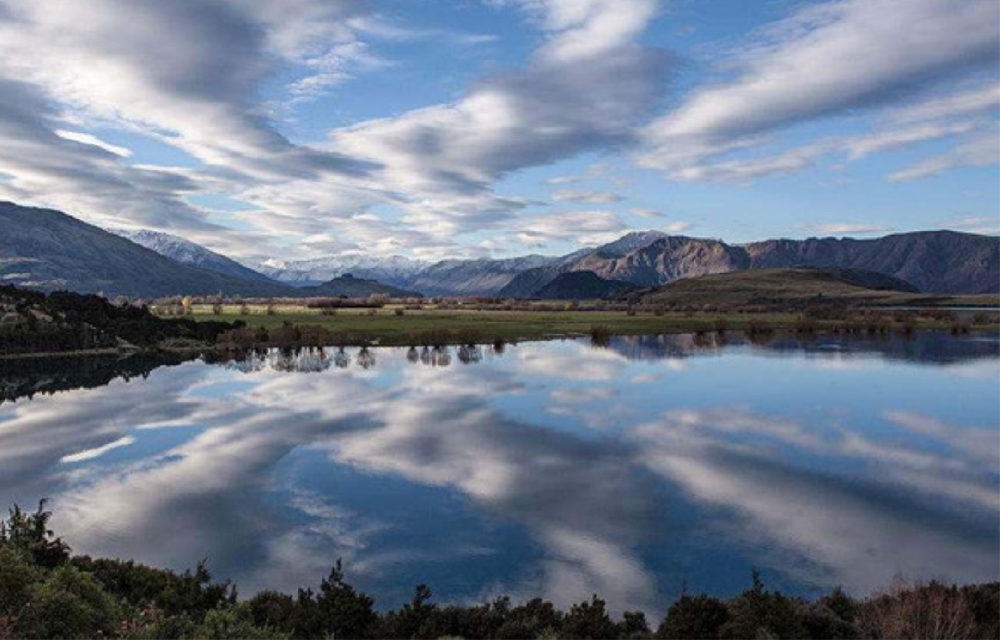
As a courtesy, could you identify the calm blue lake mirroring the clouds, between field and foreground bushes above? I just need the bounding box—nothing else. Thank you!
[0,335,1000,615]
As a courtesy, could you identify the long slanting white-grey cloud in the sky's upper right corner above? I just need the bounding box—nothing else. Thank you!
[639,0,1000,181]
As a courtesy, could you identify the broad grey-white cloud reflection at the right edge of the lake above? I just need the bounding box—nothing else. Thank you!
[633,409,998,593]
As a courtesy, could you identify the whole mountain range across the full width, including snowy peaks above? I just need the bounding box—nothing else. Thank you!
[0,202,1000,297]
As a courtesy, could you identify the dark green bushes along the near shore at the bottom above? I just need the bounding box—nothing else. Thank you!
[0,502,1000,639]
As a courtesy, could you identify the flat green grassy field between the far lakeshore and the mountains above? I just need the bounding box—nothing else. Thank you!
[160,305,996,345]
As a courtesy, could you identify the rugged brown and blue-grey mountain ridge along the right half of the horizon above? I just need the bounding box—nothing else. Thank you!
[262,230,1000,297]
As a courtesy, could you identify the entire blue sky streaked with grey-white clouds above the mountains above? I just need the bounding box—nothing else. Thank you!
[0,0,1000,263]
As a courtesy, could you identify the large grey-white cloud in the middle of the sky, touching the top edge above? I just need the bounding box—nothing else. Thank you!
[330,0,668,237]
